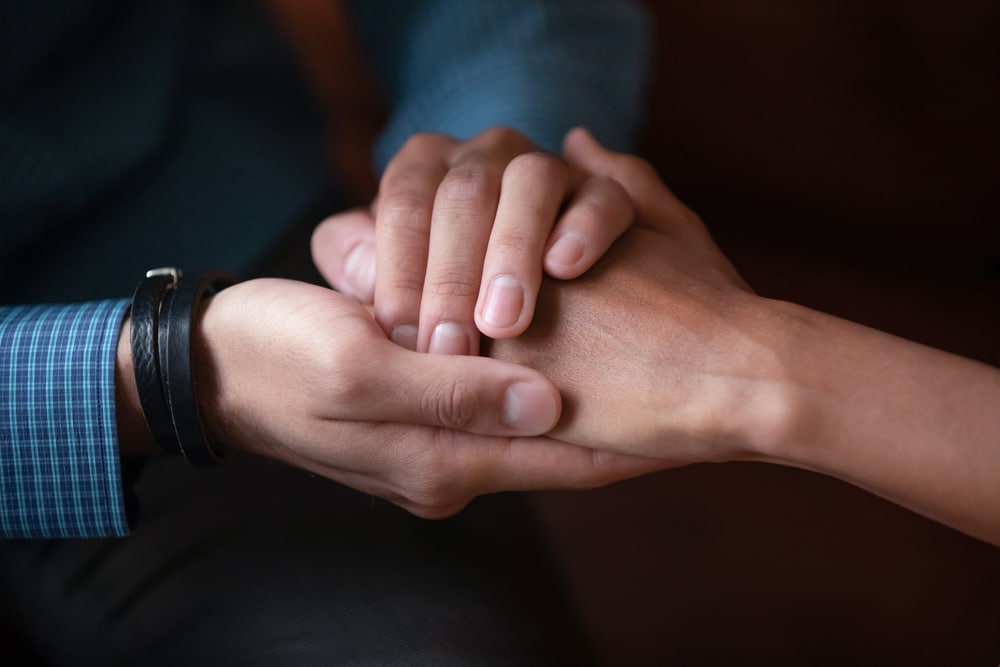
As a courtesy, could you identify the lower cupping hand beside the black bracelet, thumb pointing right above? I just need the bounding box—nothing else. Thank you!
[180,280,660,517]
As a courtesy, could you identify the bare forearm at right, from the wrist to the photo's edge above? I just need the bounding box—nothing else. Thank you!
[757,302,1000,544]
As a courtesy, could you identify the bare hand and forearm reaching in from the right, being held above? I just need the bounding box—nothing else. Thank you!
[490,133,1000,544]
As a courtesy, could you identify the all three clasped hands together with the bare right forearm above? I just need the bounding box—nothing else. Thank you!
[116,124,1000,544]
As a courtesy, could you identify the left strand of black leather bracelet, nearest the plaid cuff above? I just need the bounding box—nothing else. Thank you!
[129,269,181,454]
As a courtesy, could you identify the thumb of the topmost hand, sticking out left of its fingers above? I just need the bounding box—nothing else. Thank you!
[311,208,375,304]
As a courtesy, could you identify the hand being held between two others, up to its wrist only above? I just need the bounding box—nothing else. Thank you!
[489,131,776,464]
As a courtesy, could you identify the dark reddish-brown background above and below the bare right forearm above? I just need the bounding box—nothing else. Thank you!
[533,0,1000,666]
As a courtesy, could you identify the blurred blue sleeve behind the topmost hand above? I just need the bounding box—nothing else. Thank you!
[351,0,648,175]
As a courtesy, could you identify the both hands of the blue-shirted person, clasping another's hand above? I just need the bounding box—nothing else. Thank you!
[118,130,663,517]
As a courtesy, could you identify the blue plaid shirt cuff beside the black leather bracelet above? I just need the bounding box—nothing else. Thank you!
[0,300,129,538]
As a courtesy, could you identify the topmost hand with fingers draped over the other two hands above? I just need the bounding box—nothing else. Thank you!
[313,128,634,354]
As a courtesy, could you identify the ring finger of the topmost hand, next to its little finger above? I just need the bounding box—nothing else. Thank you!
[475,152,569,338]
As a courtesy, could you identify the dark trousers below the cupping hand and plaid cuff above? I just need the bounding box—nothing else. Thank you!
[0,457,588,666]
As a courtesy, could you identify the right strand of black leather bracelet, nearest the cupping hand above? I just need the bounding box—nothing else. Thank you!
[160,272,236,467]
